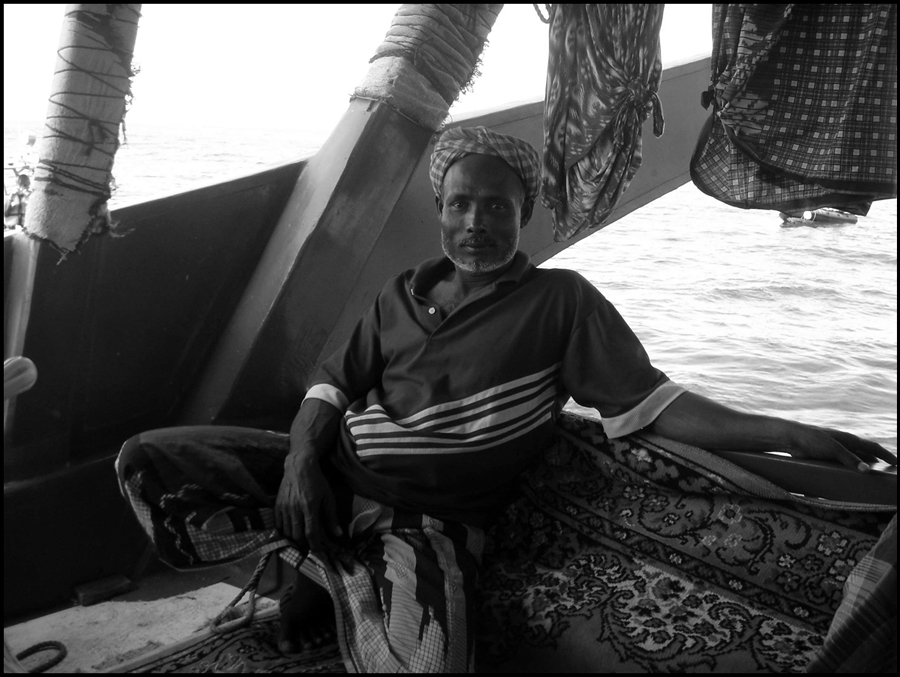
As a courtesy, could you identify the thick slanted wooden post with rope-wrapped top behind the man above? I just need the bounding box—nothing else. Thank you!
[179,5,502,425]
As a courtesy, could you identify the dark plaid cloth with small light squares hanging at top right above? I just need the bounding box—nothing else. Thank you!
[691,4,897,215]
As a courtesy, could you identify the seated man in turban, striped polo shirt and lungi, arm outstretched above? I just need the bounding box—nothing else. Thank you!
[119,127,896,671]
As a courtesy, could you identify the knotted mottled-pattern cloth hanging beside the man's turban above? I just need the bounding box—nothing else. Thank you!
[541,4,664,242]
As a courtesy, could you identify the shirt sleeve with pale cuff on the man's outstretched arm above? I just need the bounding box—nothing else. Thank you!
[562,292,684,437]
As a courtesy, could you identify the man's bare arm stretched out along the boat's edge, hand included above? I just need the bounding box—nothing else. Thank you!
[649,392,897,471]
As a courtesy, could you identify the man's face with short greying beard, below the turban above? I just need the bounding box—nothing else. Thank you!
[437,155,531,274]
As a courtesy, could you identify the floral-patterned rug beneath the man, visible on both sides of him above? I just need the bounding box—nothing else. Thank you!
[116,415,896,672]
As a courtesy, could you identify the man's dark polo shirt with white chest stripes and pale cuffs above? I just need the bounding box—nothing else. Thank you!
[306,252,684,525]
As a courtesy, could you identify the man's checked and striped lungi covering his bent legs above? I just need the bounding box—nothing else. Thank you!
[116,426,484,672]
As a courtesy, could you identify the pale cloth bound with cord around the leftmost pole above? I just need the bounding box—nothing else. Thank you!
[24,5,141,255]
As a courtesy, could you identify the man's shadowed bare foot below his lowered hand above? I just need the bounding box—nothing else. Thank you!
[278,573,335,654]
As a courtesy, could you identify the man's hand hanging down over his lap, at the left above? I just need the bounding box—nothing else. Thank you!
[275,461,341,552]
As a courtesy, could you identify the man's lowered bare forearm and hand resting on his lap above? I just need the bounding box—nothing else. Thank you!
[275,398,343,552]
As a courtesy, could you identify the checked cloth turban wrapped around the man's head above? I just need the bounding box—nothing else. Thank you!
[429,127,541,202]
